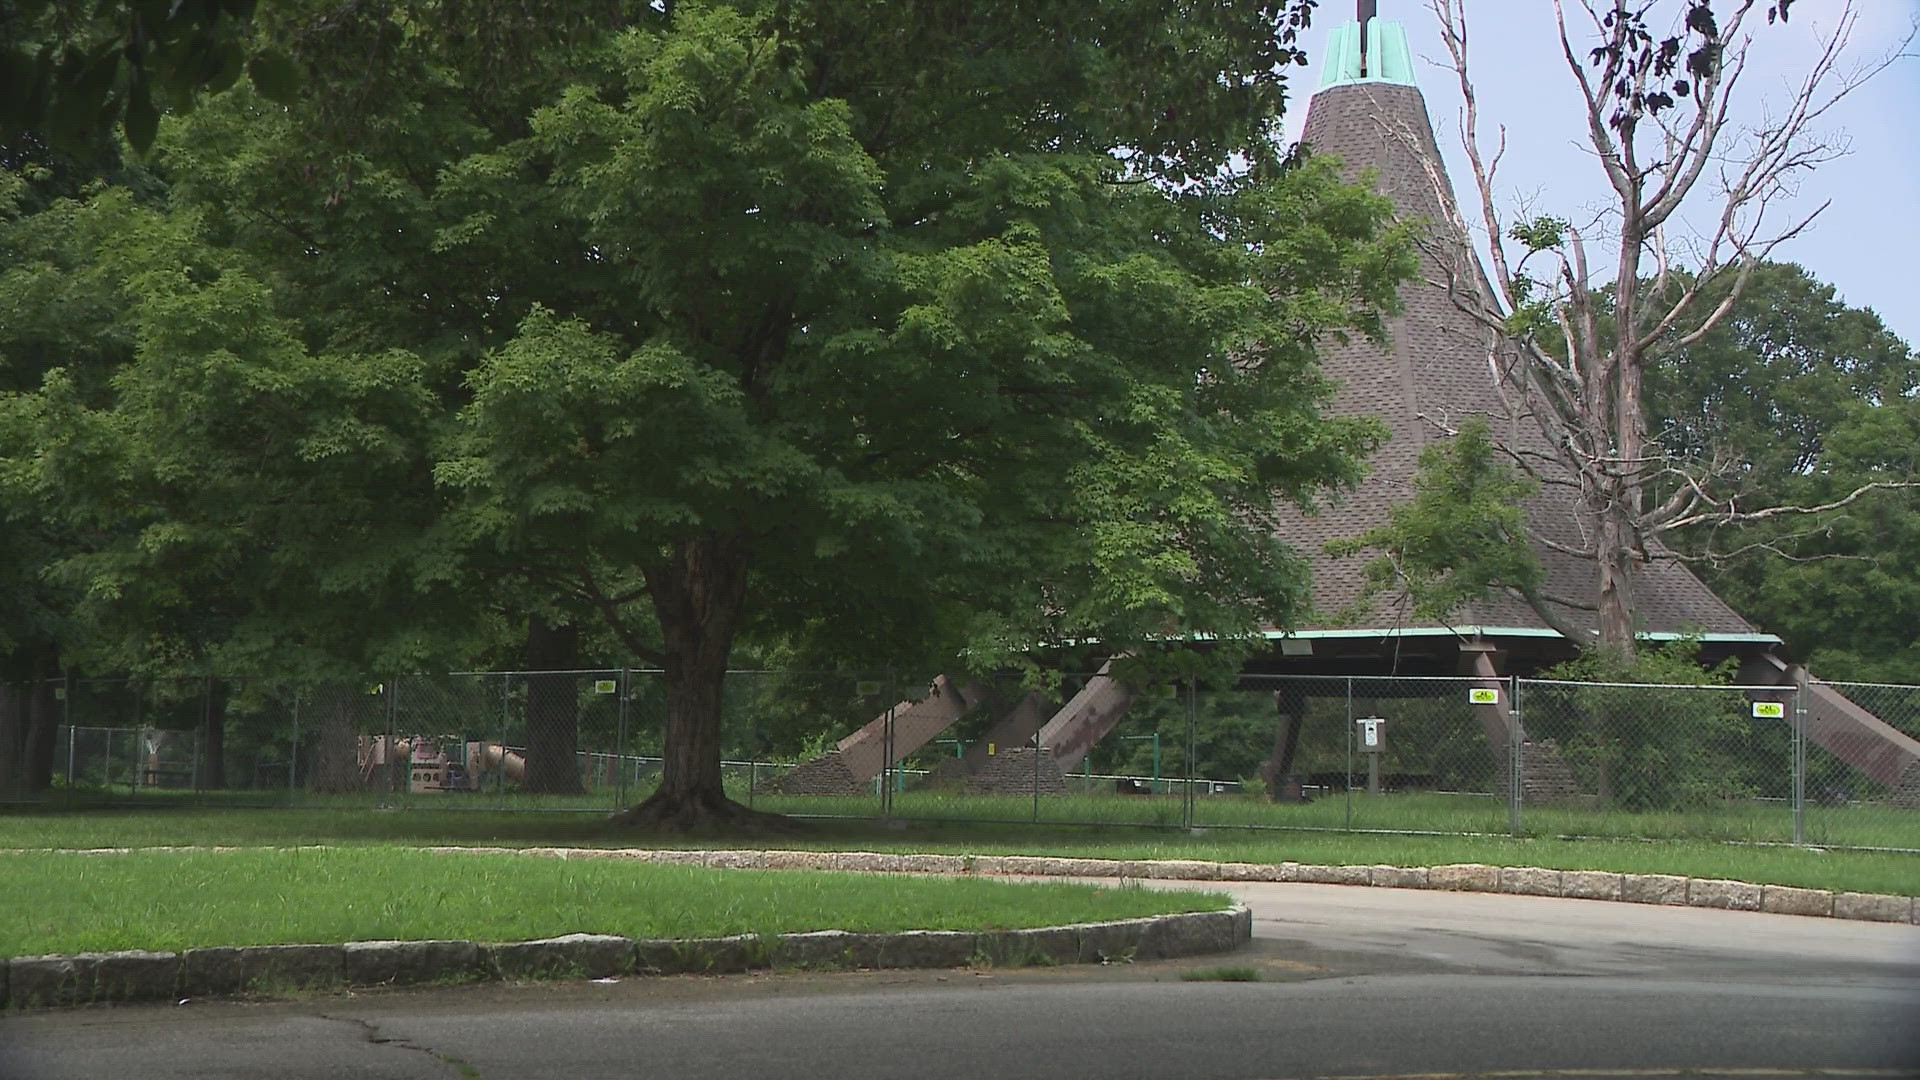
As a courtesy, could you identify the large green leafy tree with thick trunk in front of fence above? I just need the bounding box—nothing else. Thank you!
[424,4,1404,824]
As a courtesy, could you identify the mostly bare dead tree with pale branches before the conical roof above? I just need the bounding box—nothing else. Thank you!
[1428,0,1920,655]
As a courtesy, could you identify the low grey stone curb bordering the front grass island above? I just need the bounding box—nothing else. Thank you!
[0,903,1254,1011]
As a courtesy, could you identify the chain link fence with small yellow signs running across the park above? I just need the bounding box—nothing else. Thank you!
[0,669,1920,851]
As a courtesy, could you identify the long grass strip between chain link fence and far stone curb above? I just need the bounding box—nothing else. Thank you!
[0,809,1920,894]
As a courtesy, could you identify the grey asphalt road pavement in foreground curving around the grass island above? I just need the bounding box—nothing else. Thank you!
[0,884,1920,1080]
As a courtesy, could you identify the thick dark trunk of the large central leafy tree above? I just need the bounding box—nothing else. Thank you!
[618,534,785,832]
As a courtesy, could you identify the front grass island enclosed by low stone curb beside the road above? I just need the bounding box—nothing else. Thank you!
[0,847,1229,957]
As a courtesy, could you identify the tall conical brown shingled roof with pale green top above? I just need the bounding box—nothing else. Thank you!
[1279,19,1755,638]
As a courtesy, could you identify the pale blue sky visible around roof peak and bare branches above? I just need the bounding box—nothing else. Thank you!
[1286,0,1920,348]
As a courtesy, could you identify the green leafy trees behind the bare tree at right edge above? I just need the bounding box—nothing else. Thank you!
[1647,263,1920,682]
